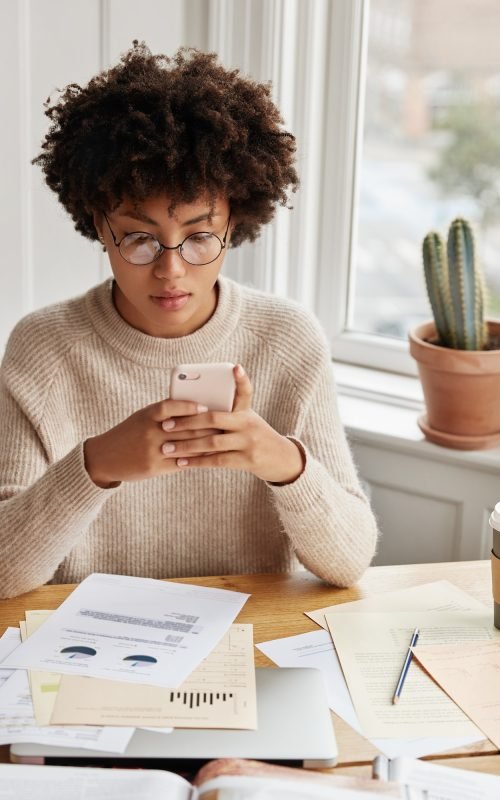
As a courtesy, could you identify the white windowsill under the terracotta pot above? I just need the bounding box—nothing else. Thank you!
[334,362,500,472]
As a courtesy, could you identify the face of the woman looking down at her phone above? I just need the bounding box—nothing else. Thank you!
[95,195,231,338]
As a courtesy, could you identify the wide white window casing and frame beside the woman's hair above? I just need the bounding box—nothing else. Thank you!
[209,0,416,375]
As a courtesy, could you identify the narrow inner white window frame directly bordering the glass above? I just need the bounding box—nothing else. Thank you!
[316,0,417,375]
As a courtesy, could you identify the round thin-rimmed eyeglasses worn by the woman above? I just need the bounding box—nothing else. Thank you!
[104,214,231,267]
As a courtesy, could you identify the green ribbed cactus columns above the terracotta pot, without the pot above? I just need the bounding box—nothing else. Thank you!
[423,219,488,350]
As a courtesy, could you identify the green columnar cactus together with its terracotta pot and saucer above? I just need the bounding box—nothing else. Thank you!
[409,219,500,450]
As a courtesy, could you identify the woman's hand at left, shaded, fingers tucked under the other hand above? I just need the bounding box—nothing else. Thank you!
[84,400,219,489]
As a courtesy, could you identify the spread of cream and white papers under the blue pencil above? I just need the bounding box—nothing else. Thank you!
[257,581,500,758]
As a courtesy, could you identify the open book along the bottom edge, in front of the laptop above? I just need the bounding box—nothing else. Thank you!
[0,759,404,800]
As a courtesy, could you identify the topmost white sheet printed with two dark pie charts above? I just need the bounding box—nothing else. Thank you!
[4,573,249,688]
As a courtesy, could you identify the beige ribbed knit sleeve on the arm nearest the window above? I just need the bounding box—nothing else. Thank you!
[238,284,378,586]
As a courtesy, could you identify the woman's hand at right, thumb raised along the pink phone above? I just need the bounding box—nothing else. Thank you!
[158,366,304,484]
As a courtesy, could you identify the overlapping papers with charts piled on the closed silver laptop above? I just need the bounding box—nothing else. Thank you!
[0,574,257,752]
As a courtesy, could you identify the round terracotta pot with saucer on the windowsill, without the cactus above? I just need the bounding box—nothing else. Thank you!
[409,321,500,450]
